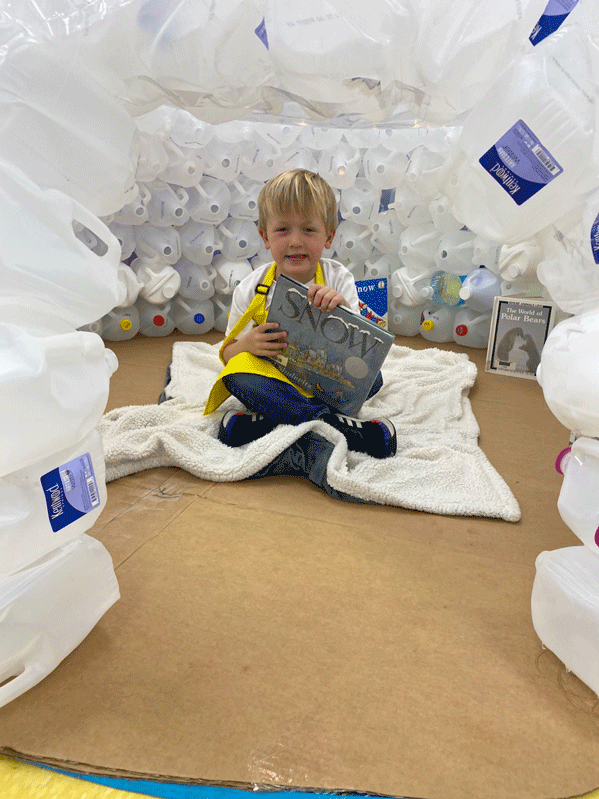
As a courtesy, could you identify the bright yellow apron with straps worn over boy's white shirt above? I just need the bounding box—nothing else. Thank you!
[204,263,324,416]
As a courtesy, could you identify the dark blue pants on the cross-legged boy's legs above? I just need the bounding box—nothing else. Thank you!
[223,372,383,424]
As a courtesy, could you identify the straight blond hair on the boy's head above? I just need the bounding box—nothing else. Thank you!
[258,169,337,233]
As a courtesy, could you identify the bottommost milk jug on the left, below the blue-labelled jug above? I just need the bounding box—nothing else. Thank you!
[0,533,119,707]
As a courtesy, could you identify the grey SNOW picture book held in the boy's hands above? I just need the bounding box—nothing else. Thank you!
[266,275,395,416]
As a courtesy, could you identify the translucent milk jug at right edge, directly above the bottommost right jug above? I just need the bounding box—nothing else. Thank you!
[557,437,599,555]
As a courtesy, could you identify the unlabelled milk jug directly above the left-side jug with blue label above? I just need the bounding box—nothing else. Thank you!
[0,324,118,476]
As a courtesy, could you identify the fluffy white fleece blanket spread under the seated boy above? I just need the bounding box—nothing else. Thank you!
[98,342,520,522]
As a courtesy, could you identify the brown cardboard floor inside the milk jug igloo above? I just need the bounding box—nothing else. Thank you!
[0,333,599,799]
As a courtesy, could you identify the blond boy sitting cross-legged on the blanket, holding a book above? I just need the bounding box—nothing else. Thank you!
[205,169,396,458]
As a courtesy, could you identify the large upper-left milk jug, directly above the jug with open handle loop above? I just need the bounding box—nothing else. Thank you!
[0,40,139,216]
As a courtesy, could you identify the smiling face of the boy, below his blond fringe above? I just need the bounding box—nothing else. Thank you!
[260,213,335,283]
